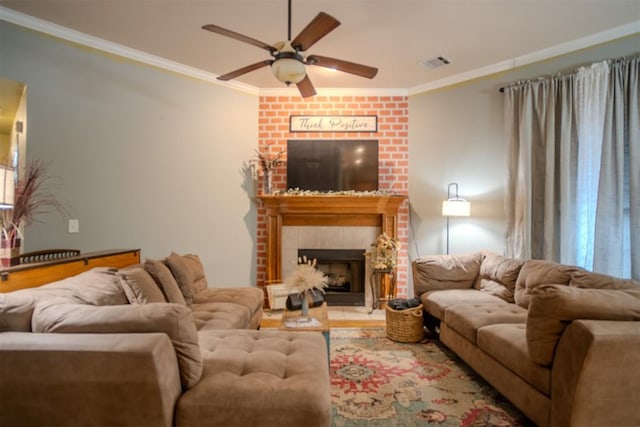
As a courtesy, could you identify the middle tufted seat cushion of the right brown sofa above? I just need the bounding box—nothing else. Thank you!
[444,300,527,344]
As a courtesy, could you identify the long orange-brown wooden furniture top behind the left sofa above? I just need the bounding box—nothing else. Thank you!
[0,249,140,292]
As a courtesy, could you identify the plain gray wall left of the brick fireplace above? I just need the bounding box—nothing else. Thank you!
[0,22,258,286]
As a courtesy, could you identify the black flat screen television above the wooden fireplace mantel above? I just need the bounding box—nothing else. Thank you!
[287,139,378,191]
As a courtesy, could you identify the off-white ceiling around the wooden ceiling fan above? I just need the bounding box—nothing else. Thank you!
[0,0,640,92]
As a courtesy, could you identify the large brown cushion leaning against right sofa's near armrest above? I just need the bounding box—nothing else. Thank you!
[527,285,640,366]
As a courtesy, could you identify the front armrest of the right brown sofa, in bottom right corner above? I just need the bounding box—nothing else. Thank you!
[551,320,640,427]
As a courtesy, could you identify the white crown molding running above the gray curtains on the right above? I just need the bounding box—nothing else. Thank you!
[408,20,640,95]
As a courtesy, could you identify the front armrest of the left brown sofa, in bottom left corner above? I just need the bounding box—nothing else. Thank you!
[0,332,182,426]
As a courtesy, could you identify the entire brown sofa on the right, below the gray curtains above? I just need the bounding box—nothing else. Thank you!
[412,252,640,427]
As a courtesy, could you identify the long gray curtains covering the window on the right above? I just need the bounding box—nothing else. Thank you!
[504,57,640,279]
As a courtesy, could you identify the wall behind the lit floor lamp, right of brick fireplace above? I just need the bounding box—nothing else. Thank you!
[409,35,640,259]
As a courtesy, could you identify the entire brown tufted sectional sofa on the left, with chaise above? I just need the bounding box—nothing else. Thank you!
[0,254,331,427]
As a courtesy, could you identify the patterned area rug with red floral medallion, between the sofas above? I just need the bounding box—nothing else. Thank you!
[331,328,533,427]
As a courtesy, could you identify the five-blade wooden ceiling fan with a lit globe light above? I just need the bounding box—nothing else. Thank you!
[202,0,378,98]
